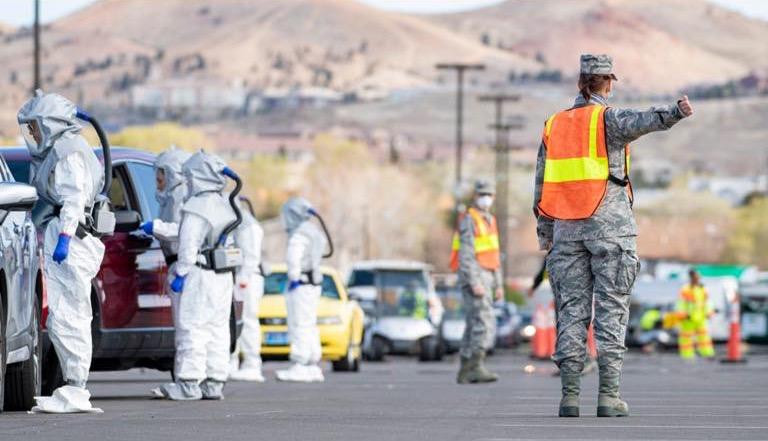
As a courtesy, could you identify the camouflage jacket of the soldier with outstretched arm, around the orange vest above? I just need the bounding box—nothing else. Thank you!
[533,95,683,249]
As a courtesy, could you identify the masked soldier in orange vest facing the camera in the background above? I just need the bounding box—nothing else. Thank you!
[451,181,504,384]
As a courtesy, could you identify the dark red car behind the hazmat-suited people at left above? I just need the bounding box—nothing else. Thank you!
[0,148,242,395]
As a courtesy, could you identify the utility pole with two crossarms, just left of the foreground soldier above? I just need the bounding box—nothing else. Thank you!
[479,94,522,275]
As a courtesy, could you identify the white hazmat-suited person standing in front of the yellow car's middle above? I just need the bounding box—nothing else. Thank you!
[277,198,330,382]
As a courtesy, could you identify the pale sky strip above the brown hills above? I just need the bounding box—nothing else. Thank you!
[0,0,768,25]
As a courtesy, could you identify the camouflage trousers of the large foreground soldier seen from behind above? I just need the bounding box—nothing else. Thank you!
[547,236,640,376]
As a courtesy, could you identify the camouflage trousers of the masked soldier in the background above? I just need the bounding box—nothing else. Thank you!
[459,272,496,358]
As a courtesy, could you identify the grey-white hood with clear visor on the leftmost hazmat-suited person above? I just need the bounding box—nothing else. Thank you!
[17,89,82,160]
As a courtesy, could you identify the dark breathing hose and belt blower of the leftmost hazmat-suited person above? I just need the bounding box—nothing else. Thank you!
[75,109,116,237]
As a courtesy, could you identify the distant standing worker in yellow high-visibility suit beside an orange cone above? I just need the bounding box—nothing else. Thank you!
[675,269,715,360]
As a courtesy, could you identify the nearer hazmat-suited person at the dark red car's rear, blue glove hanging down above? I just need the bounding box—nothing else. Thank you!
[153,150,242,400]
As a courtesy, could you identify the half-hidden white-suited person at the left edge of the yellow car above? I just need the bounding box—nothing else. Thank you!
[229,203,264,383]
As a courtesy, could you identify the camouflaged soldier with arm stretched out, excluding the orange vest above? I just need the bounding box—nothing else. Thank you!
[534,55,693,416]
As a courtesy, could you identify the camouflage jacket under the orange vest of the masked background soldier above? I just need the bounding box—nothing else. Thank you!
[459,208,503,290]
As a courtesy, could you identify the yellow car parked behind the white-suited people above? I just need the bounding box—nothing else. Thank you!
[259,265,364,372]
